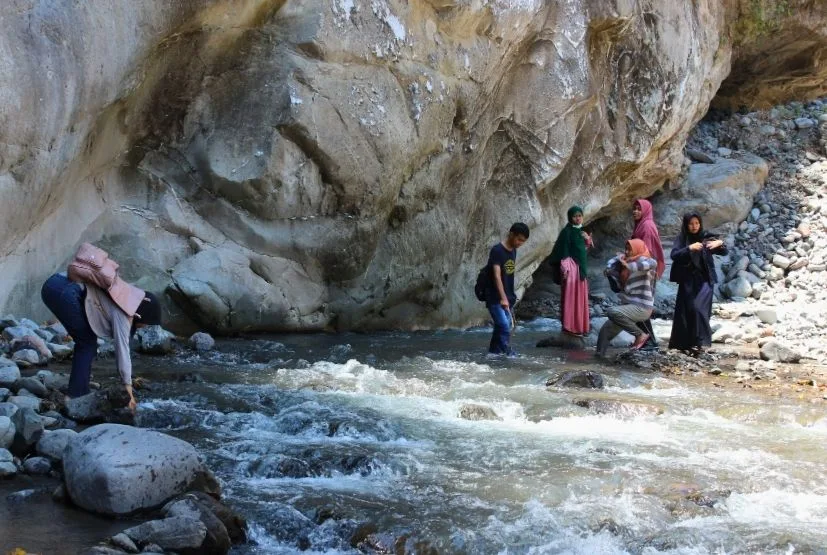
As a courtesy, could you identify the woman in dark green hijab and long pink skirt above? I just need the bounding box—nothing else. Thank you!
[549,206,593,336]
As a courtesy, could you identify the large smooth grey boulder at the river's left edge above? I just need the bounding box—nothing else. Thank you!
[63,424,217,516]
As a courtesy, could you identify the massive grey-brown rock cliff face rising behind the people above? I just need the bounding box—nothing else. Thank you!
[0,0,824,333]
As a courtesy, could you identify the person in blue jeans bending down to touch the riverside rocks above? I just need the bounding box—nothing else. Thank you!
[40,273,161,410]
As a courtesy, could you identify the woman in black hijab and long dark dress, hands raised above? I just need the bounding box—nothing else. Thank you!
[669,212,727,356]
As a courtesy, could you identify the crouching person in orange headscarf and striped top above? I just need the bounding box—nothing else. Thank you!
[596,239,658,358]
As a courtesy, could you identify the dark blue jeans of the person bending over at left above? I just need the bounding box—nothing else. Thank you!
[40,274,98,397]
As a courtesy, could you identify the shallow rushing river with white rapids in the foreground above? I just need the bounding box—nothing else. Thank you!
[1,322,827,554]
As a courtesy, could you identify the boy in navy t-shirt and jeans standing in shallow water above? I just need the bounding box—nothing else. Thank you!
[485,222,529,355]
